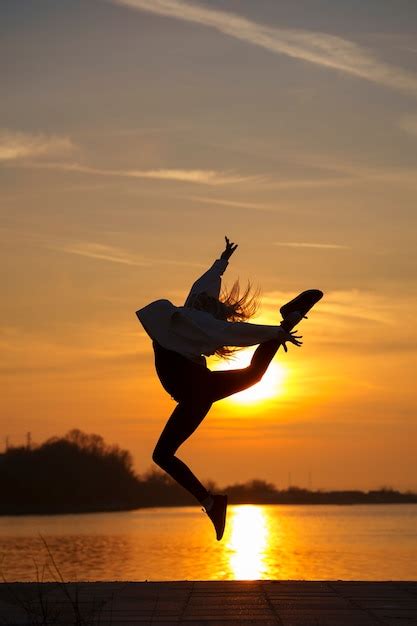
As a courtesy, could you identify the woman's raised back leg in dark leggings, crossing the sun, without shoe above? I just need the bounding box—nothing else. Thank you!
[208,339,281,402]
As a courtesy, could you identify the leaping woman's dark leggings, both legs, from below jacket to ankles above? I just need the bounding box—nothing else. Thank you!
[152,339,281,502]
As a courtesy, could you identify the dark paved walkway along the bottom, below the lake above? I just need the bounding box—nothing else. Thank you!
[0,581,417,626]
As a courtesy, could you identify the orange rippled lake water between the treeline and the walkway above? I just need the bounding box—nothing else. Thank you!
[0,505,417,581]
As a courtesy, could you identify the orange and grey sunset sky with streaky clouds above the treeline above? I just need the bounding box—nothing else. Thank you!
[0,0,417,490]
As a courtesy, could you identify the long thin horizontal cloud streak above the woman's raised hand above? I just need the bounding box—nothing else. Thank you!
[26,162,255,186]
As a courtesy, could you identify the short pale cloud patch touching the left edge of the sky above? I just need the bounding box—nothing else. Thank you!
[0,129,74,162]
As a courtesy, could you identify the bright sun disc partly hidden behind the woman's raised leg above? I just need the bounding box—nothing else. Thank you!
[213,350,287,404]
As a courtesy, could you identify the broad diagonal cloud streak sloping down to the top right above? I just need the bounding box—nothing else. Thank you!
[112,0,417,96]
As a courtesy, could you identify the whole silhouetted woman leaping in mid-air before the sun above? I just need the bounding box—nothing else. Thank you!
[136,237,323,540]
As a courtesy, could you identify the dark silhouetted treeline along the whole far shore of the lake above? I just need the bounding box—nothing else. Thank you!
[0,430,417,515]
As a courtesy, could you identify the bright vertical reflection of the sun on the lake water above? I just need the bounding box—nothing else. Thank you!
[227,505,269,580]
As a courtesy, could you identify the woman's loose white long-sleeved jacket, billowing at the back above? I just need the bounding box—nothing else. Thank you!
[136,259,286,364]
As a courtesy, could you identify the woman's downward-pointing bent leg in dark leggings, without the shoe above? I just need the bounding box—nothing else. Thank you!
[152,401,211,502]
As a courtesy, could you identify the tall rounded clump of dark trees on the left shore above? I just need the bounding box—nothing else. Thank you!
[0,429,139,513]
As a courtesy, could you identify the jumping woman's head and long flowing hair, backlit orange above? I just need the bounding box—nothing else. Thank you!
[192,280,260,359]
